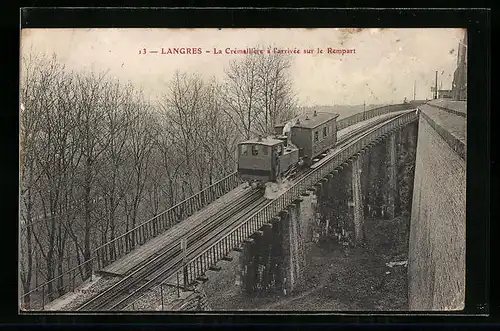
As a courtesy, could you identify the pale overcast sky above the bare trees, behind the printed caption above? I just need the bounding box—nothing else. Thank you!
[21,29,464,106]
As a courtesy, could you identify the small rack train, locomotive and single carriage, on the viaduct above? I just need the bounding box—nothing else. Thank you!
[238,111,339,188]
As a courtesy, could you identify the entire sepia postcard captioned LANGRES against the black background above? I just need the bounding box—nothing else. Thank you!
[18,28,468,313]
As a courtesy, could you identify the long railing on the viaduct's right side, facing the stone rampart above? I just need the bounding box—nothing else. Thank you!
[183,110,418,284]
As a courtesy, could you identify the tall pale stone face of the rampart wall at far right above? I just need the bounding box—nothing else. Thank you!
[408,112,466,310]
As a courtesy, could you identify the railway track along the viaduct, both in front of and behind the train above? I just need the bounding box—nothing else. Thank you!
[72,110,412,311]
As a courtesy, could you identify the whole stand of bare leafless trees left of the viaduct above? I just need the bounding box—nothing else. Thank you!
[20,46,302,305]
